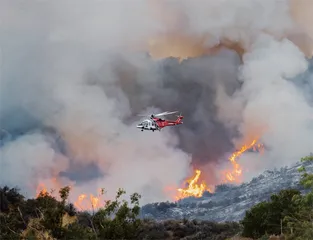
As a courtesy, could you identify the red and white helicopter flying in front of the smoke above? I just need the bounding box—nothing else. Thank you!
[137,111,184,132]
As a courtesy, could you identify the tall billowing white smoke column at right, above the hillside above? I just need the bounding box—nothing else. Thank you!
[234,36,313,178]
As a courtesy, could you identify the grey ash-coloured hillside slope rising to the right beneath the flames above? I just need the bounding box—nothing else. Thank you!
[141,159,313,222]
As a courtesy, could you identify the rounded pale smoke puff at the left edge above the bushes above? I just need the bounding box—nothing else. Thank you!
[0,133,69,191]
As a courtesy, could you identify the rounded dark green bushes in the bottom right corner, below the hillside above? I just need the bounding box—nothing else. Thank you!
[241,156,313,240]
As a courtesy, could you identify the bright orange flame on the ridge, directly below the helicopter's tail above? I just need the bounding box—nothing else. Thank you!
[176,169,211,200]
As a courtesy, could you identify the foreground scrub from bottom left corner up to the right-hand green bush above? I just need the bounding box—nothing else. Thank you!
[0,187,240,240]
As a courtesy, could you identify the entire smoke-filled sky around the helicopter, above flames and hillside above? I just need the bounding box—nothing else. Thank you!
[0,0,313,202]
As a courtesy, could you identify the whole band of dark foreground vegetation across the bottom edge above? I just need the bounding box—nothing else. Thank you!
[0,156,313,240]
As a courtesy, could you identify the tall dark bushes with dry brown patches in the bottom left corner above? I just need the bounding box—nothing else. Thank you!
[0,187,141,239]
